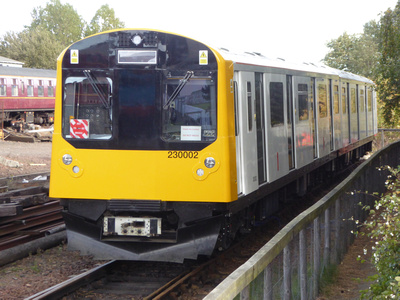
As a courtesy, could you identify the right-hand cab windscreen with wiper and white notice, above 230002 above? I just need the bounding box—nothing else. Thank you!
[162,72,217,142]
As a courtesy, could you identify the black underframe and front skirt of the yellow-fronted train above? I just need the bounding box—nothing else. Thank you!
[61,137,372,262]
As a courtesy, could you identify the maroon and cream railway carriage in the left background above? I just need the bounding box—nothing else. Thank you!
[0,66,57,125]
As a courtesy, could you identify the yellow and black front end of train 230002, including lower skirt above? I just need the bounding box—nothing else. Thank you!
[50,30,237,261]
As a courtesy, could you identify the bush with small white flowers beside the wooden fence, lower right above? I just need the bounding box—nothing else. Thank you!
[362,166,400,299]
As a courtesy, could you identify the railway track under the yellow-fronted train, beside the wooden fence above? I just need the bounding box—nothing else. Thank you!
[22,161,366,299]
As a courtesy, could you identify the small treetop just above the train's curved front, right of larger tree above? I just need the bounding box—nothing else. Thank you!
[85,4,125,36]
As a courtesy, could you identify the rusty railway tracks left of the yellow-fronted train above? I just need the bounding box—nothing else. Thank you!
[0,173,65,255]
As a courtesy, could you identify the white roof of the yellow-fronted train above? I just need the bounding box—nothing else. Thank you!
[218,48,374,84]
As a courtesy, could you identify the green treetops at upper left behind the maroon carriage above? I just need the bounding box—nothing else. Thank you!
[0,0,125,69]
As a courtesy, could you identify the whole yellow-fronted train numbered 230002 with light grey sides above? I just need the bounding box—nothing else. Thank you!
[50,29,377,262]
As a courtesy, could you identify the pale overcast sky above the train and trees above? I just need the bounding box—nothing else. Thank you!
[0,0,397,62]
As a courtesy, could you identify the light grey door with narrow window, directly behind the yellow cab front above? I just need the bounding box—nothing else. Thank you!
[235,72,258,195]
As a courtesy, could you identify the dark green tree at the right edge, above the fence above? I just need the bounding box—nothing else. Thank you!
[376,3,400,127]
